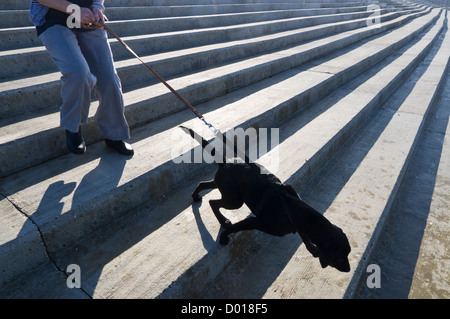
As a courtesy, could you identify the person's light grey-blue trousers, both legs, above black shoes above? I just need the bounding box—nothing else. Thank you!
[39,25,130,140]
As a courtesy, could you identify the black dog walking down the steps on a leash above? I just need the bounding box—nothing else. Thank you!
[181,126,351,272]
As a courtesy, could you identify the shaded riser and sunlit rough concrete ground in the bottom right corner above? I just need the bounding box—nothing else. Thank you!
[355,35,450,299]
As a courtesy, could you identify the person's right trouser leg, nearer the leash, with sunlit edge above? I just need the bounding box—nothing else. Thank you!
[76,29,130,141]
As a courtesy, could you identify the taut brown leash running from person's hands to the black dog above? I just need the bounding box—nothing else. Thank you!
[98,21,247,161]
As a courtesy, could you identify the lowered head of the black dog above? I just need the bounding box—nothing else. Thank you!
[319,225,351,272]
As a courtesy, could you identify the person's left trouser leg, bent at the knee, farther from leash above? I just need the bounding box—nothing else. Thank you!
[40,25,97,133]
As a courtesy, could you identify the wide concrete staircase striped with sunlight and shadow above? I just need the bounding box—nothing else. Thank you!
[0,0,450,298]
